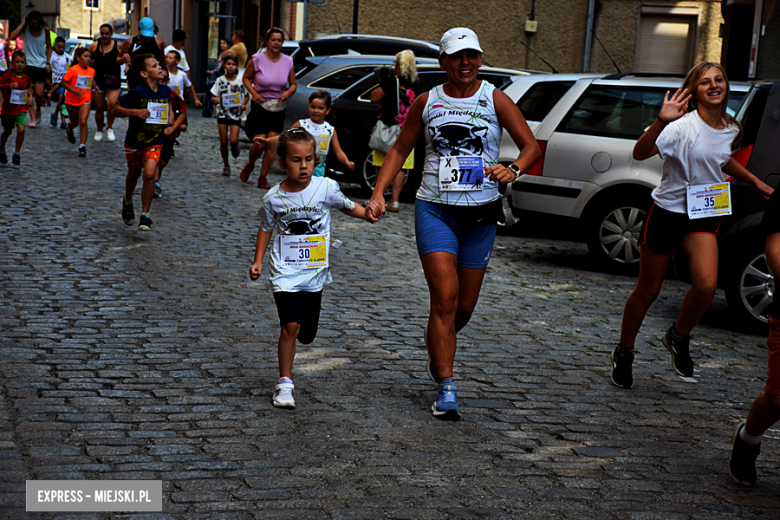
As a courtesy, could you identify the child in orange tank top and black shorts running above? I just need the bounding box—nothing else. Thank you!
[60,47,95,157]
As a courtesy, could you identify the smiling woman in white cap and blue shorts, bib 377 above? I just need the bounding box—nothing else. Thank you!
[370,27,540,419]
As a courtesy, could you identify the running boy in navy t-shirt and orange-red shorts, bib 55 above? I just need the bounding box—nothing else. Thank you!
[114,54,173,231]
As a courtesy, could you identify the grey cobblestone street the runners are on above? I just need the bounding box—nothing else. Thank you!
[0,106,780,520]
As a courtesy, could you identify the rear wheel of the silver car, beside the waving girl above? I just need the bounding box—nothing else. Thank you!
[585,194,648,268]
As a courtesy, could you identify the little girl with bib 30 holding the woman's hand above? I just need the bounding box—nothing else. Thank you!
[249,128,370,408]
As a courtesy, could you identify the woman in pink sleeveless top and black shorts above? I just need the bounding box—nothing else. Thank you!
[239,27,298,190]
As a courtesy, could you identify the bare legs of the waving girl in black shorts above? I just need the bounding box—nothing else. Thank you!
[620,233,718,347]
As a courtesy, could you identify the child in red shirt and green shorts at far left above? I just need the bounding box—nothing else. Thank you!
[0,51,34,166]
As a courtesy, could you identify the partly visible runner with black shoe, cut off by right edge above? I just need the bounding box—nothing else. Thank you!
[729,190,780,486]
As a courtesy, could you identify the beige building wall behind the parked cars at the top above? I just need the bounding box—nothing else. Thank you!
[308,0,723,72]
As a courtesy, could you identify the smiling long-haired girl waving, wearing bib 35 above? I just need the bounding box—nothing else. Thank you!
[611,62,773,388]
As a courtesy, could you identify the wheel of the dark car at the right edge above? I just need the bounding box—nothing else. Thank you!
[724,248,775,325]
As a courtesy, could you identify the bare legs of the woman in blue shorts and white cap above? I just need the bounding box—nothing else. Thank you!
[422,252,485,378]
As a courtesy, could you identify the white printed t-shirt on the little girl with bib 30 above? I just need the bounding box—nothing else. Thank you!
[257,177,355,292]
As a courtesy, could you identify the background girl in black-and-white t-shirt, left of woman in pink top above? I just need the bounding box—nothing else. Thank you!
[211,54,249,177]
